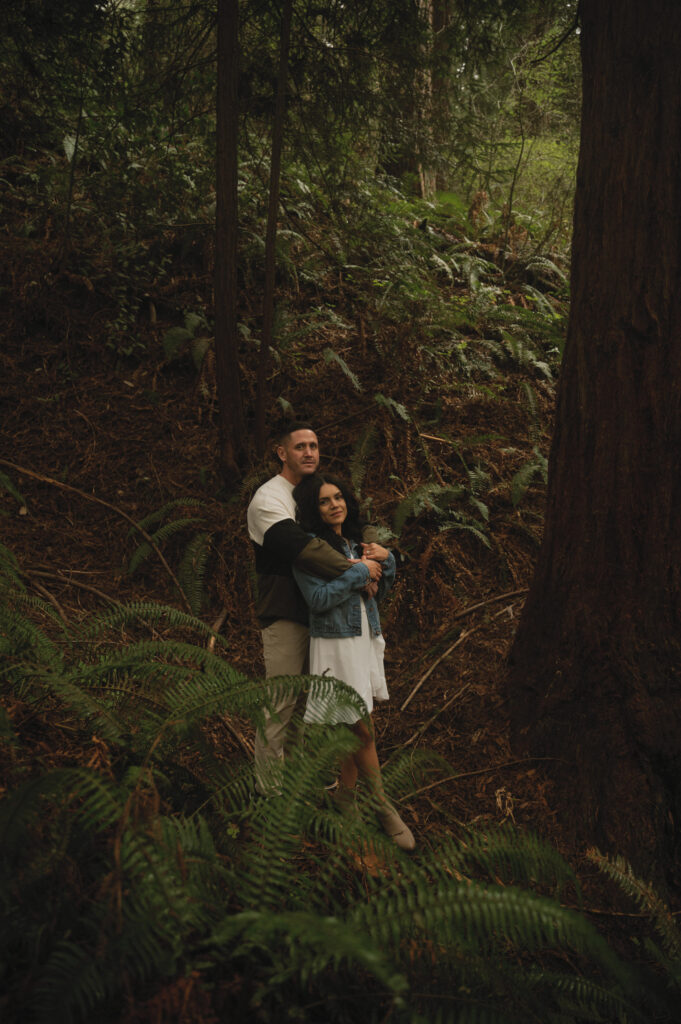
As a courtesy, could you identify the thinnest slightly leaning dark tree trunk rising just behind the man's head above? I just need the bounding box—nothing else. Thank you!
[255,0,293,456]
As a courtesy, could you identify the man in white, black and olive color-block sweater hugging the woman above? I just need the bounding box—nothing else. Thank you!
[247,422,381,794]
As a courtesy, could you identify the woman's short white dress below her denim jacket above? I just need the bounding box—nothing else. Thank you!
[304,599,388,725]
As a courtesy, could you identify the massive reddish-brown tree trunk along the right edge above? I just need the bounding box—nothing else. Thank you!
[509,0,681,882]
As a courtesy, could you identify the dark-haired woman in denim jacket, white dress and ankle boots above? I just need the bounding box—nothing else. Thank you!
[293,473,416,850]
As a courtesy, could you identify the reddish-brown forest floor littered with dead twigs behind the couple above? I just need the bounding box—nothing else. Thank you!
[0,249,562,845]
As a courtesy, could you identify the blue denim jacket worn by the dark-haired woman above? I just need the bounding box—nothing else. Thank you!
[293,545,395,637]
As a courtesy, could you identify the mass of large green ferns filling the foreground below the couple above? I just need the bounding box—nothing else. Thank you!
[0,550,679,1024]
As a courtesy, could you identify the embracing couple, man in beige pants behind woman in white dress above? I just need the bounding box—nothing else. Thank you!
[248,422,416,850]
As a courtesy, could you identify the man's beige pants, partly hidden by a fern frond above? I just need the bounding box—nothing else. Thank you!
[255,618,309,794]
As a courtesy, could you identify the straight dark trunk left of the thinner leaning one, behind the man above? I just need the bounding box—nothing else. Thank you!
[215,0,246,480]
